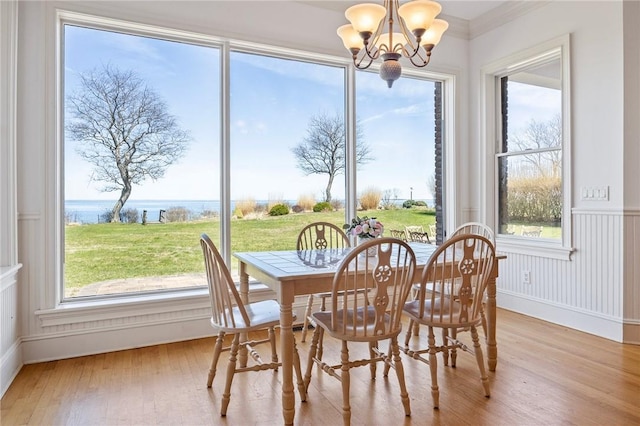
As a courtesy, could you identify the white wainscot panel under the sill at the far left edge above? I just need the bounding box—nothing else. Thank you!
[0,264,22,397]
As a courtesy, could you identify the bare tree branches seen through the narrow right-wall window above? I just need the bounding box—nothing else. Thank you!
[509,114,562,177]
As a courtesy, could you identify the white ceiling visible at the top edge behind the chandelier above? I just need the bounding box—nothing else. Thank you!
[298,0,508,21]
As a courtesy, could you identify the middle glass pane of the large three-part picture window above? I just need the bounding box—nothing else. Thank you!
[231,52,345,274]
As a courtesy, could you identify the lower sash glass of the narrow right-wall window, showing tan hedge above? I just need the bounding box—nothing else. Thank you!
[499,151,562,238]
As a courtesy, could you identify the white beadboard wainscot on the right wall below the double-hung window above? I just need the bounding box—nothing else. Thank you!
[497,209,628,342]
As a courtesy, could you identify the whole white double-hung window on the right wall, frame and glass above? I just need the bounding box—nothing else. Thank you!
[484,36,571,258]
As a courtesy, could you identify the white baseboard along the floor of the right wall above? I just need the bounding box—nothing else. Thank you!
[497,291,633,343]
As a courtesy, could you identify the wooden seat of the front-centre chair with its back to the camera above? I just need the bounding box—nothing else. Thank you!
[311,306,400,342]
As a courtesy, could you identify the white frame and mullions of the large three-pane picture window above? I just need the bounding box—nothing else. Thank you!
[52,9,457,308]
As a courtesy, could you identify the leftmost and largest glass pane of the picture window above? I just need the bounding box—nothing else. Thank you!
[63,25,220,298]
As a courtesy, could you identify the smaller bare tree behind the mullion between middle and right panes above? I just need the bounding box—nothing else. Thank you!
[292,114,372,201]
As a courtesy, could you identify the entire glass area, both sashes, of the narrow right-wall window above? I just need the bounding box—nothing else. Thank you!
[498,56,563,239]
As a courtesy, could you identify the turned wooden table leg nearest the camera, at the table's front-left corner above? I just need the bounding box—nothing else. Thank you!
[280,296,295,425]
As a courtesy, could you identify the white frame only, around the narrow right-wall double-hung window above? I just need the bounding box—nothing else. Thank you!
[480,34,574,260]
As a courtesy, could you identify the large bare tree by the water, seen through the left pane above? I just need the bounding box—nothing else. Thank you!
[66,65,191,222]
